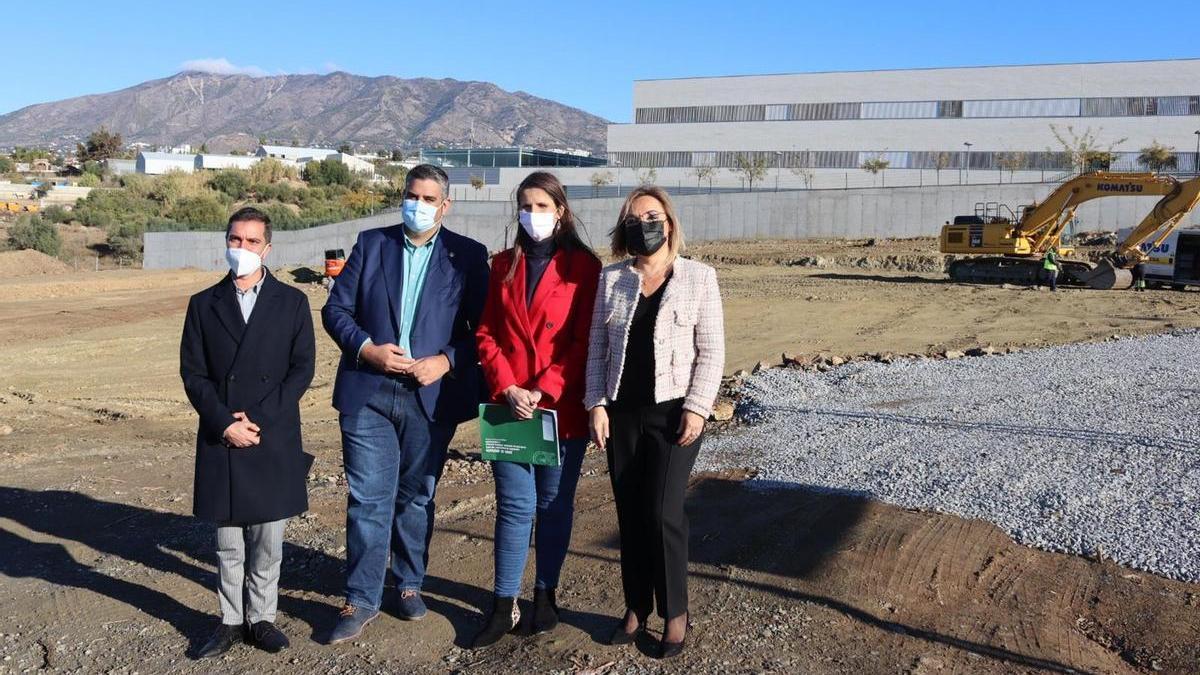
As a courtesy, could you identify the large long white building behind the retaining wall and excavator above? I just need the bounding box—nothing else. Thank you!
[607,59,1200,189]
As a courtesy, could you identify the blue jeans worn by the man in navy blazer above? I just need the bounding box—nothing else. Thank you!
[338,380,455,609]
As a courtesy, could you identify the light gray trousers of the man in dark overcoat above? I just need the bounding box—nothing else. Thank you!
[217,518,288,626]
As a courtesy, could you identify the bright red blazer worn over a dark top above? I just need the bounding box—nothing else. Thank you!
[475,249,600,438]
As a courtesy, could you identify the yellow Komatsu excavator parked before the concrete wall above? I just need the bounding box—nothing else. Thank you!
[940,172,1200,289]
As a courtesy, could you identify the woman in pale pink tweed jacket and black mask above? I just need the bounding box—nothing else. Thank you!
[583,185,725,657]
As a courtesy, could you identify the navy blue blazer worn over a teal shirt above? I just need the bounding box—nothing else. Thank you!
[320,225,488,424]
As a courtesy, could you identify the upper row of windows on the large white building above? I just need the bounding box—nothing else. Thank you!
[634,96,1200,124]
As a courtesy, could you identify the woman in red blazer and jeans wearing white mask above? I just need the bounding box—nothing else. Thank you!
[474,172,600,647]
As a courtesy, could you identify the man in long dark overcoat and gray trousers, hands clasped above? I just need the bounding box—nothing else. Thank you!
[179,207,316,658]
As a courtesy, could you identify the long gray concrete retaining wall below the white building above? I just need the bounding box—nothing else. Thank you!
[143,184,1200,269]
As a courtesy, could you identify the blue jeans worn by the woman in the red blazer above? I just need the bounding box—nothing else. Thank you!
[492,438,588,598]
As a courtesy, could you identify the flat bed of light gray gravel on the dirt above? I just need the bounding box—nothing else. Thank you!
[700,330,1200,581]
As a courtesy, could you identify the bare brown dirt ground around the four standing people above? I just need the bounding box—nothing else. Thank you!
[0,241,1200,674]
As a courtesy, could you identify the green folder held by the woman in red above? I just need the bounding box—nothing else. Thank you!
[479,404,563,466]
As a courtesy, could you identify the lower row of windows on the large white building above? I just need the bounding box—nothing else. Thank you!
[608,150,1196,173]
